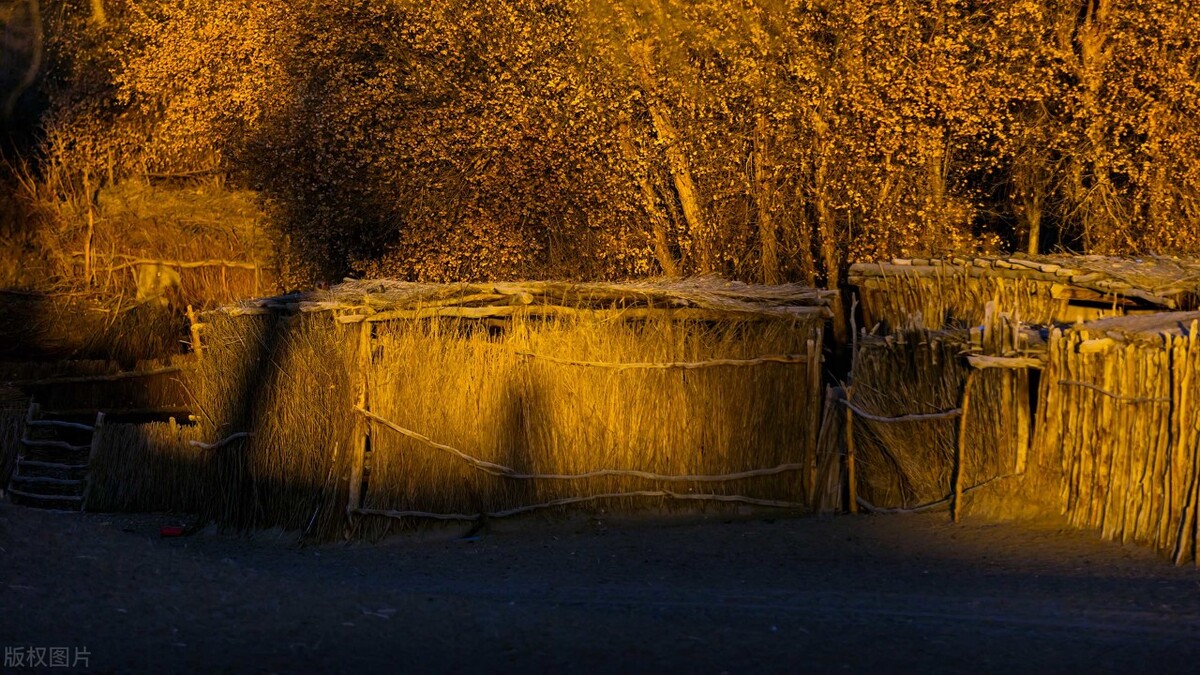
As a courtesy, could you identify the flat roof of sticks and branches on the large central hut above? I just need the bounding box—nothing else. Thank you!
[221,277,838,323]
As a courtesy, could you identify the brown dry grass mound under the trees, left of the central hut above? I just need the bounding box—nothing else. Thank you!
[0,172,275,363]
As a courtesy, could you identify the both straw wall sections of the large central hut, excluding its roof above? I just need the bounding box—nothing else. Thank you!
[192,287,823,539]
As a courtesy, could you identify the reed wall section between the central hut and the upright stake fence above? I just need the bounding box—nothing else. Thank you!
[842,329,1030,510]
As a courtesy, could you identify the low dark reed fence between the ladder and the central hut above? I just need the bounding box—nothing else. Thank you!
[84,423,216,513]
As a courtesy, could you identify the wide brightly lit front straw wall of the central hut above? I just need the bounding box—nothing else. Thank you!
[364,318,821,526]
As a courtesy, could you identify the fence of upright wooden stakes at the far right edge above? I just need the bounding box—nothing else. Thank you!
[1036,312,1200,562]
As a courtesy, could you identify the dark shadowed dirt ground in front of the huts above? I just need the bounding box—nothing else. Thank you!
[0,504,1200,673]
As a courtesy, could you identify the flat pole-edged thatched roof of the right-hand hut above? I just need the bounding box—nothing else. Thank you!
[850,256,1200,310]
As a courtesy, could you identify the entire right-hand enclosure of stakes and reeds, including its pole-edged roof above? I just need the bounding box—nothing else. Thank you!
[847,256,1200,562]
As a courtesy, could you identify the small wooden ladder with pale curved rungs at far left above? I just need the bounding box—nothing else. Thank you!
[7,402,104,510]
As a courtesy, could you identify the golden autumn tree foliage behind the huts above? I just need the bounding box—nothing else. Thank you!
[9,0,1200,285]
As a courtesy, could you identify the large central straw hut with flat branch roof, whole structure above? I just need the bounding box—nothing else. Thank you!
[113,280,835,538]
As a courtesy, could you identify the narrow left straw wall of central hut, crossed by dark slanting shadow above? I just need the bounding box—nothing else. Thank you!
[190,313,356,538]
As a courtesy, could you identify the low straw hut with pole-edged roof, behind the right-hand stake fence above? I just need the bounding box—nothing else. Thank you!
[850,256,1200,327]
